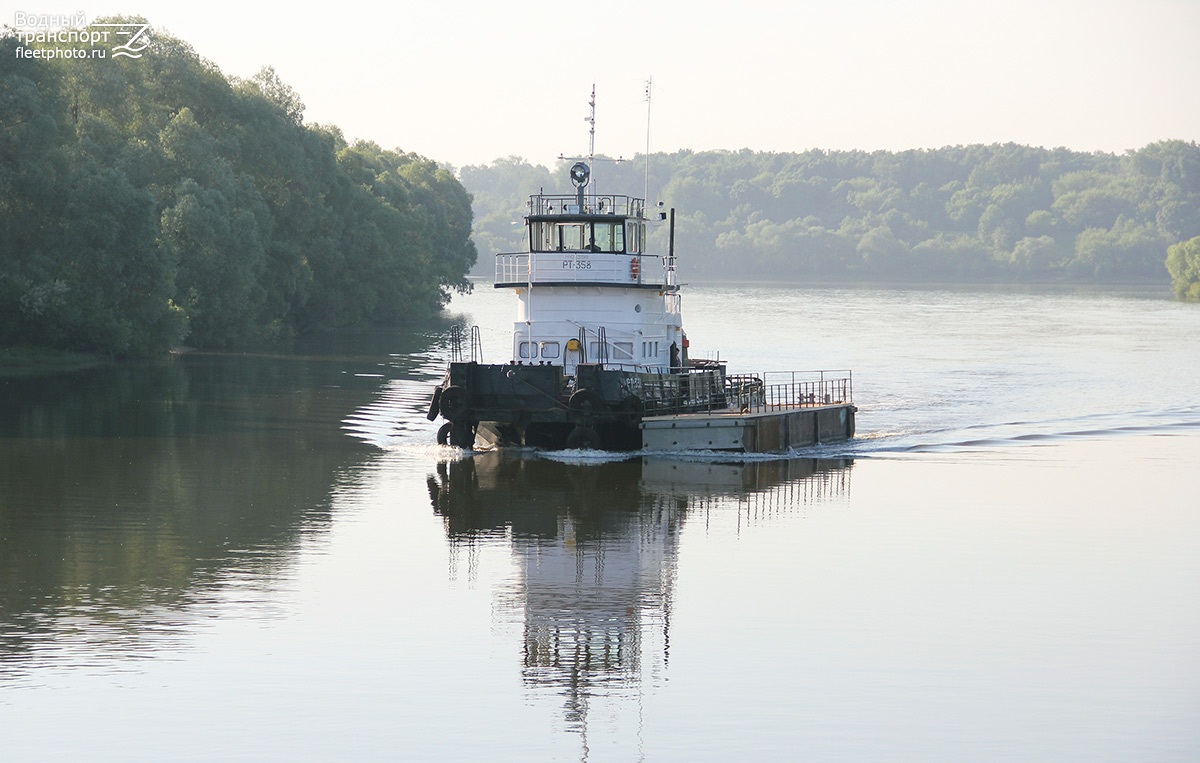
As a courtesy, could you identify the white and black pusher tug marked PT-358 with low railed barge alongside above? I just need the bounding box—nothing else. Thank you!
[428,162,857,452]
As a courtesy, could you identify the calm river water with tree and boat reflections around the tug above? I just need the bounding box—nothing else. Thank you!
[0,284,1200,762]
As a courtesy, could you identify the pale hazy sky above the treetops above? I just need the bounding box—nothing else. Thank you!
[18,0,1200,166]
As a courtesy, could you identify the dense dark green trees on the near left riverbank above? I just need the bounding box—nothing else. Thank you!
[0,19,475,355]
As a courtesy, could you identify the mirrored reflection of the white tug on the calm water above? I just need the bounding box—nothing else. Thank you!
[428,451,852,733]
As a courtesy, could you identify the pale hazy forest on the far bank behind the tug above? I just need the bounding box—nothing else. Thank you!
[460,140,1200,295]
